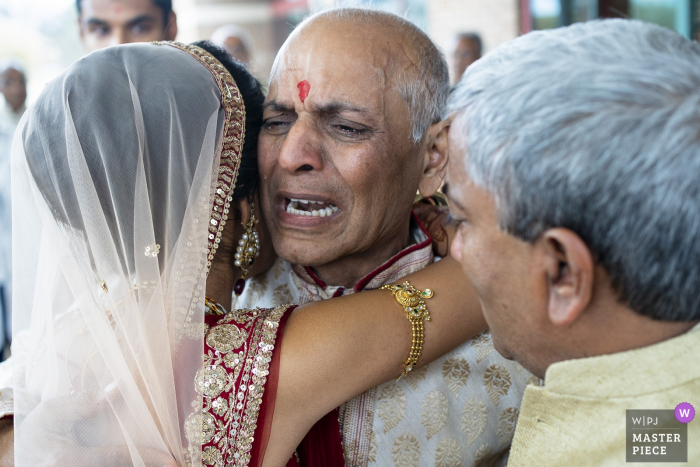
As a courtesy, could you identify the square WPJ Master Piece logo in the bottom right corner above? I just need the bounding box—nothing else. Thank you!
[627,406,694,462]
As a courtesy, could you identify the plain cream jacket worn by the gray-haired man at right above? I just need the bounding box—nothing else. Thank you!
[508,326,700,467]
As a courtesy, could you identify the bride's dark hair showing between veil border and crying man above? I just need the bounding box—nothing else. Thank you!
[192,41,265,205]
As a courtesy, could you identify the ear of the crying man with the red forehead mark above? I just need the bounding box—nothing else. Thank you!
[418,120,450,197]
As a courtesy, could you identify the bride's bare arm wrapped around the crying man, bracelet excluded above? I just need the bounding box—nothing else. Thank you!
[264,257,486,466]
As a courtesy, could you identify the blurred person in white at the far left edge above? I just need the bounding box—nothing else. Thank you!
[0,60,27,359]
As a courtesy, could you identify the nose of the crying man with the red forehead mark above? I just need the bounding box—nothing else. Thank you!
[278,119,323,173]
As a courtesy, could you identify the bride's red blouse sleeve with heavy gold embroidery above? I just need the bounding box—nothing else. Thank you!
[194,305,295,467]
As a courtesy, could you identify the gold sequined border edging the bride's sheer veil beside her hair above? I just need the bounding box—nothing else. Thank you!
[154,41,245,273]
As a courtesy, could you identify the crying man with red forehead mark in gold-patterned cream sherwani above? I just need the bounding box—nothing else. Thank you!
[241,9,530,467]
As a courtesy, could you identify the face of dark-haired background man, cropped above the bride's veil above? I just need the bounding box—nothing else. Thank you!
[78,0,177,52]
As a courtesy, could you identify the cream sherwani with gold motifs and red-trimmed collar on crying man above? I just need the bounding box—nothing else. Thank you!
[235,228,539,467]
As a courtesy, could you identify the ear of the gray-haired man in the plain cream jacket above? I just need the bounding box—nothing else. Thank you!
[538,228,595,326]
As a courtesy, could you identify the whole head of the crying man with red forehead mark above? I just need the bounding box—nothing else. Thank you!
[258,9,449,287]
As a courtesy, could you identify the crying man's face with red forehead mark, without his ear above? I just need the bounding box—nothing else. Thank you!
[258,21,422,266]
